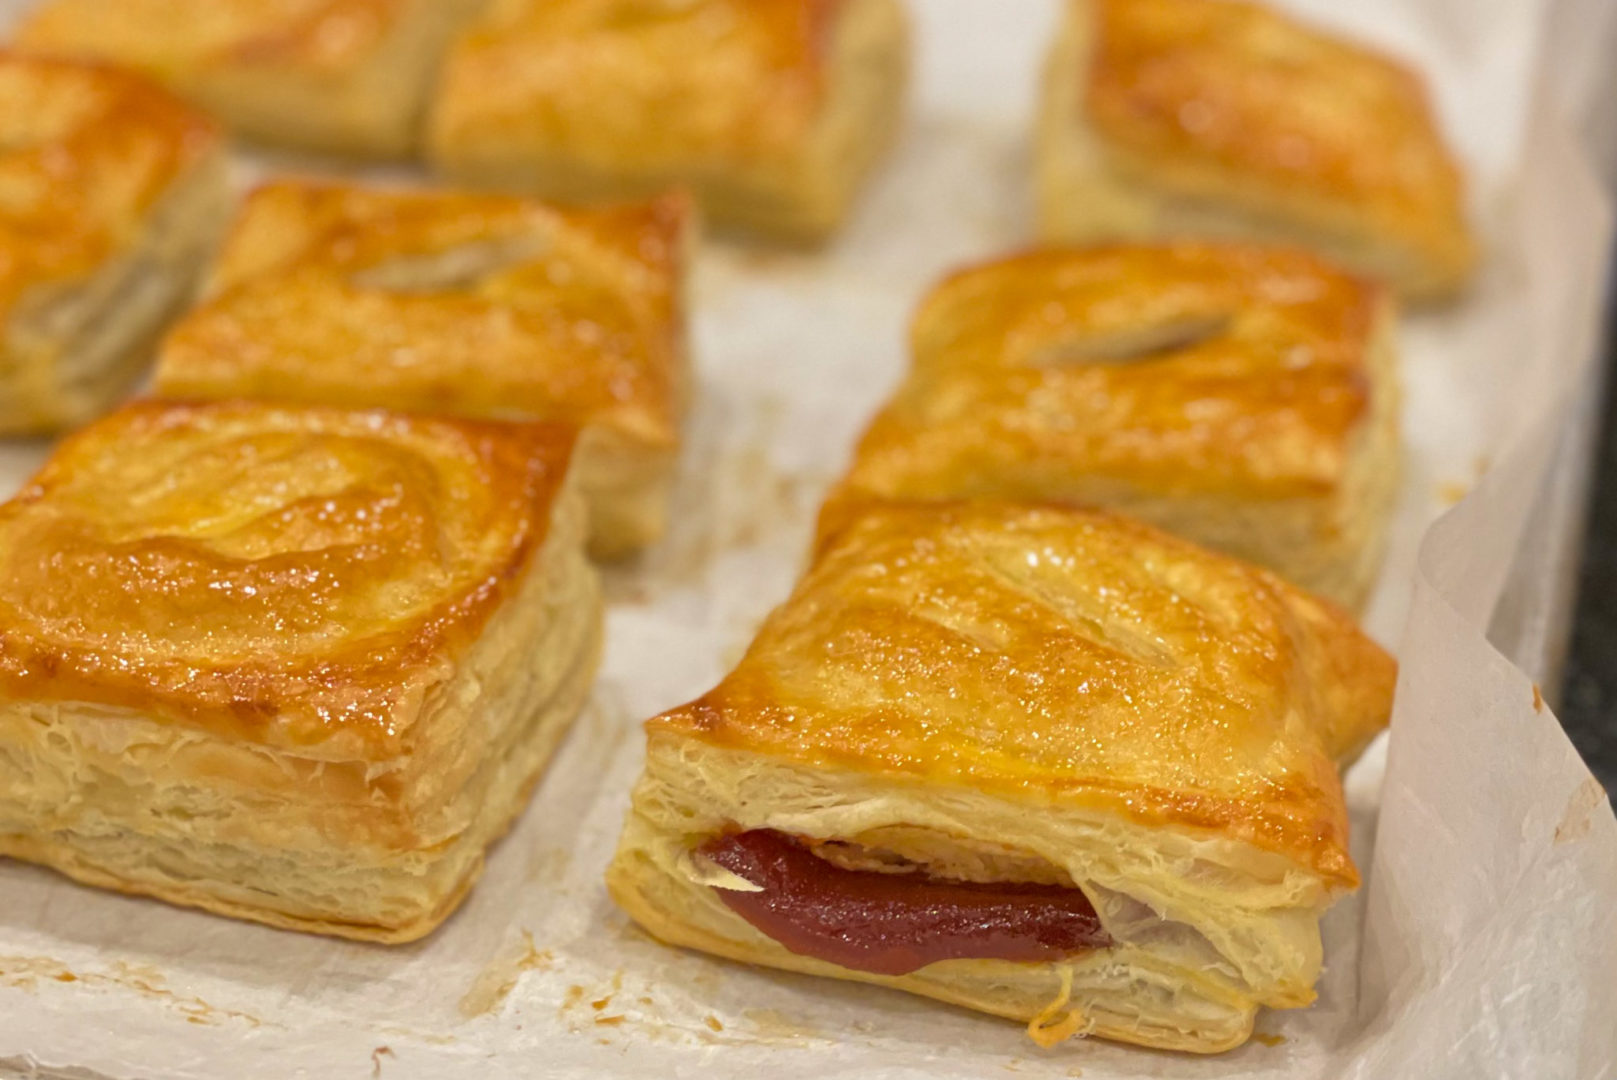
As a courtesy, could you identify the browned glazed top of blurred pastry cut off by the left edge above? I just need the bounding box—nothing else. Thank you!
[0,50,220,327]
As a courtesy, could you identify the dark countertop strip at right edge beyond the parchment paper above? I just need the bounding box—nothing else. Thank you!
[1559,297,1617,795]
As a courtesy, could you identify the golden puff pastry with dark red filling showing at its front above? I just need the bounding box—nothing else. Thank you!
[608,503,1394,1051]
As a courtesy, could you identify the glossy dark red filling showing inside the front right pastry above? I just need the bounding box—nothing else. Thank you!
[697,829,1111,975]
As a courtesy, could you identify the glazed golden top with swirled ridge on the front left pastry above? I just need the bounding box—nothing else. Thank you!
[0,403,574,755]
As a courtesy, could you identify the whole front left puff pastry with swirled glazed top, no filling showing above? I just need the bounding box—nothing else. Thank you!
[0,403,600,941]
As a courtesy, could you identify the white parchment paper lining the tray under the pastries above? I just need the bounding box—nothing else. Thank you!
[0,0,1617,1080]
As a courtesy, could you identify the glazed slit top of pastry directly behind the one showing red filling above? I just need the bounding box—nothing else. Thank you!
[844,244,1387,498]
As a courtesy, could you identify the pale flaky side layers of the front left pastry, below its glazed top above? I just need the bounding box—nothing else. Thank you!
[0,478,602,943]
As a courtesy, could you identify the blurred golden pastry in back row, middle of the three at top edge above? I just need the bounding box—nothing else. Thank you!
[429,0,909,241]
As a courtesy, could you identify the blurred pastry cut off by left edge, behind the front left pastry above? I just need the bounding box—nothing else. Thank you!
[0,50,226,435]
